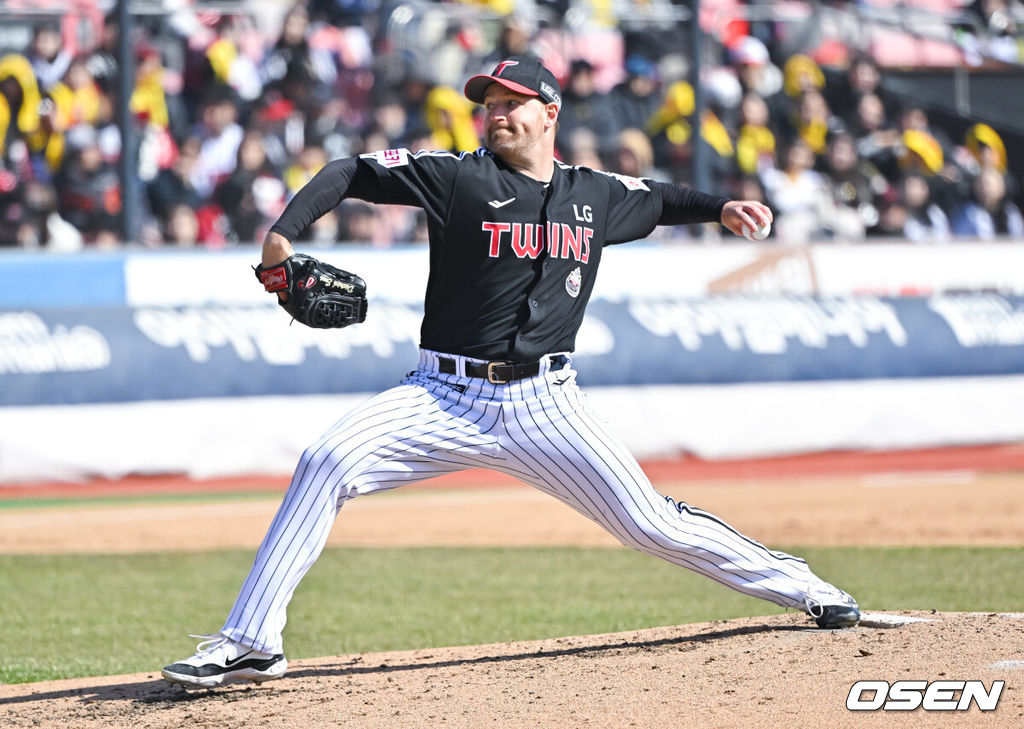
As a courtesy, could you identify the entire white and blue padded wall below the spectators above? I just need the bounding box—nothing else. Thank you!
[0,243,1024,483]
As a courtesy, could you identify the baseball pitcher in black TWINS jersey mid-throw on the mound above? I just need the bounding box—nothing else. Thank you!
[162,56,860,687]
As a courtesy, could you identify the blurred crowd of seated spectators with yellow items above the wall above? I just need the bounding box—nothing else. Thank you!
[0,0,1024,250]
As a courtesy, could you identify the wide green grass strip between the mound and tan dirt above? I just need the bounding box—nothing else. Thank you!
[0,548,1024,683]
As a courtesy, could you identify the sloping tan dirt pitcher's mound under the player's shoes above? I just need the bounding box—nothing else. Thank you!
[0,613,1024,729]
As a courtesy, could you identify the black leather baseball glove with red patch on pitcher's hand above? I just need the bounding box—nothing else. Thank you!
[255,253,367,329]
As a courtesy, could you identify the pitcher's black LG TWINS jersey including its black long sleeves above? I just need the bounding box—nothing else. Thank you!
[272,148,725,361]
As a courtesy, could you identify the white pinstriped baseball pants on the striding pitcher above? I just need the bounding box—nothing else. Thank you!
[221,350,812,653]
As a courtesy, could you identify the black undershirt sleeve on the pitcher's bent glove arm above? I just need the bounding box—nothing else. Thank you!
[270,157,391,241]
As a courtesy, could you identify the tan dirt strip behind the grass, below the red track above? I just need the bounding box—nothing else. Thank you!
[0,471,1024,554]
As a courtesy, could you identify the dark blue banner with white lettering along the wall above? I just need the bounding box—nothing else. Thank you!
[0,294,1024,406]
